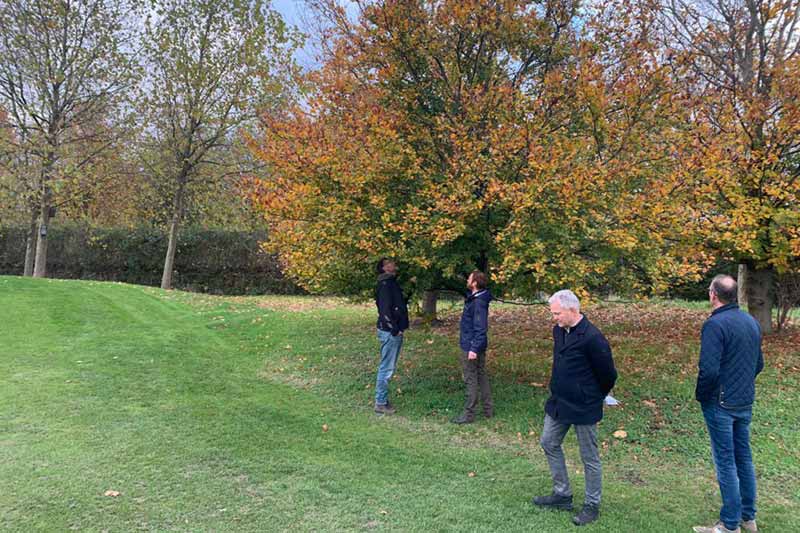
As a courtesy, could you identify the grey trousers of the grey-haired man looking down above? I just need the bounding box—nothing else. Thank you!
[540,415,603,505]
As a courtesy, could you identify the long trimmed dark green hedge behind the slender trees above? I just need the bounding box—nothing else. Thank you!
[0,225,303,294]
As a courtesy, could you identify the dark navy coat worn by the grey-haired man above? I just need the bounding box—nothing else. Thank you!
[544,316,617,425]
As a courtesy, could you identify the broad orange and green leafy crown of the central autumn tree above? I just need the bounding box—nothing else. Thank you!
[252,0,692,312]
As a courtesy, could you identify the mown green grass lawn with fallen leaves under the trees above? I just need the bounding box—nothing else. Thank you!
[0,277,800,532]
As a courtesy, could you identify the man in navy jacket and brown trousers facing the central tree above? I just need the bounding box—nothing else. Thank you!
[452,270,494,424]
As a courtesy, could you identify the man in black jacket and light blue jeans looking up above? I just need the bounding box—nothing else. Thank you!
[375,257,408,414]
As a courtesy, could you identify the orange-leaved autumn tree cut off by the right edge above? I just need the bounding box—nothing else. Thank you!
[639,0,800,332]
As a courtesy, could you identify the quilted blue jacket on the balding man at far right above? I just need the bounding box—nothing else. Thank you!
[695,304,764,409]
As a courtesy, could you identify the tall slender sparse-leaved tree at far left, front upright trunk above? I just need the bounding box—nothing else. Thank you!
[0,0,136,277]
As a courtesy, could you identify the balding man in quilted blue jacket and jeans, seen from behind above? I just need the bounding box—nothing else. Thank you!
[694,275,764,533]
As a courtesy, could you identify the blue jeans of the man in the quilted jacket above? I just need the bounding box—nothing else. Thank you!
[702,402,756,529]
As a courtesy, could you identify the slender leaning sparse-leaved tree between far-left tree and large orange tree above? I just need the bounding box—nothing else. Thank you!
[140,0,297,289]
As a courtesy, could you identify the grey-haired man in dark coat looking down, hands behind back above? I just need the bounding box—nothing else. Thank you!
[533,290,617,526]
